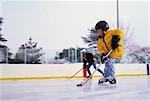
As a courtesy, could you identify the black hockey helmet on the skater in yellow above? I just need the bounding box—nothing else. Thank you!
[95,20,109,31]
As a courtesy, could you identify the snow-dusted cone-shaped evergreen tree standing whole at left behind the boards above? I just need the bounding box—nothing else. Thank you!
[15,38,44,64]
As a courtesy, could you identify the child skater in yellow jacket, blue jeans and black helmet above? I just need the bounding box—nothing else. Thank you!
[95,21,124,84]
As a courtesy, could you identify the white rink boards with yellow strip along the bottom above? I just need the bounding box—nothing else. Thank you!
[0,63,147,80]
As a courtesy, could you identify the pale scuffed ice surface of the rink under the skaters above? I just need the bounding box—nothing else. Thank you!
[0,76,150,101]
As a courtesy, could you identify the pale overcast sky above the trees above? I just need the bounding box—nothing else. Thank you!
[0,0,150,57]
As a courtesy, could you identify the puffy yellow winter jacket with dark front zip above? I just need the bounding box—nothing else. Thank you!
[97,29,124,59]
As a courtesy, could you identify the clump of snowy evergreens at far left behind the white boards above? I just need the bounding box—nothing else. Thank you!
[0,17,44,64]
